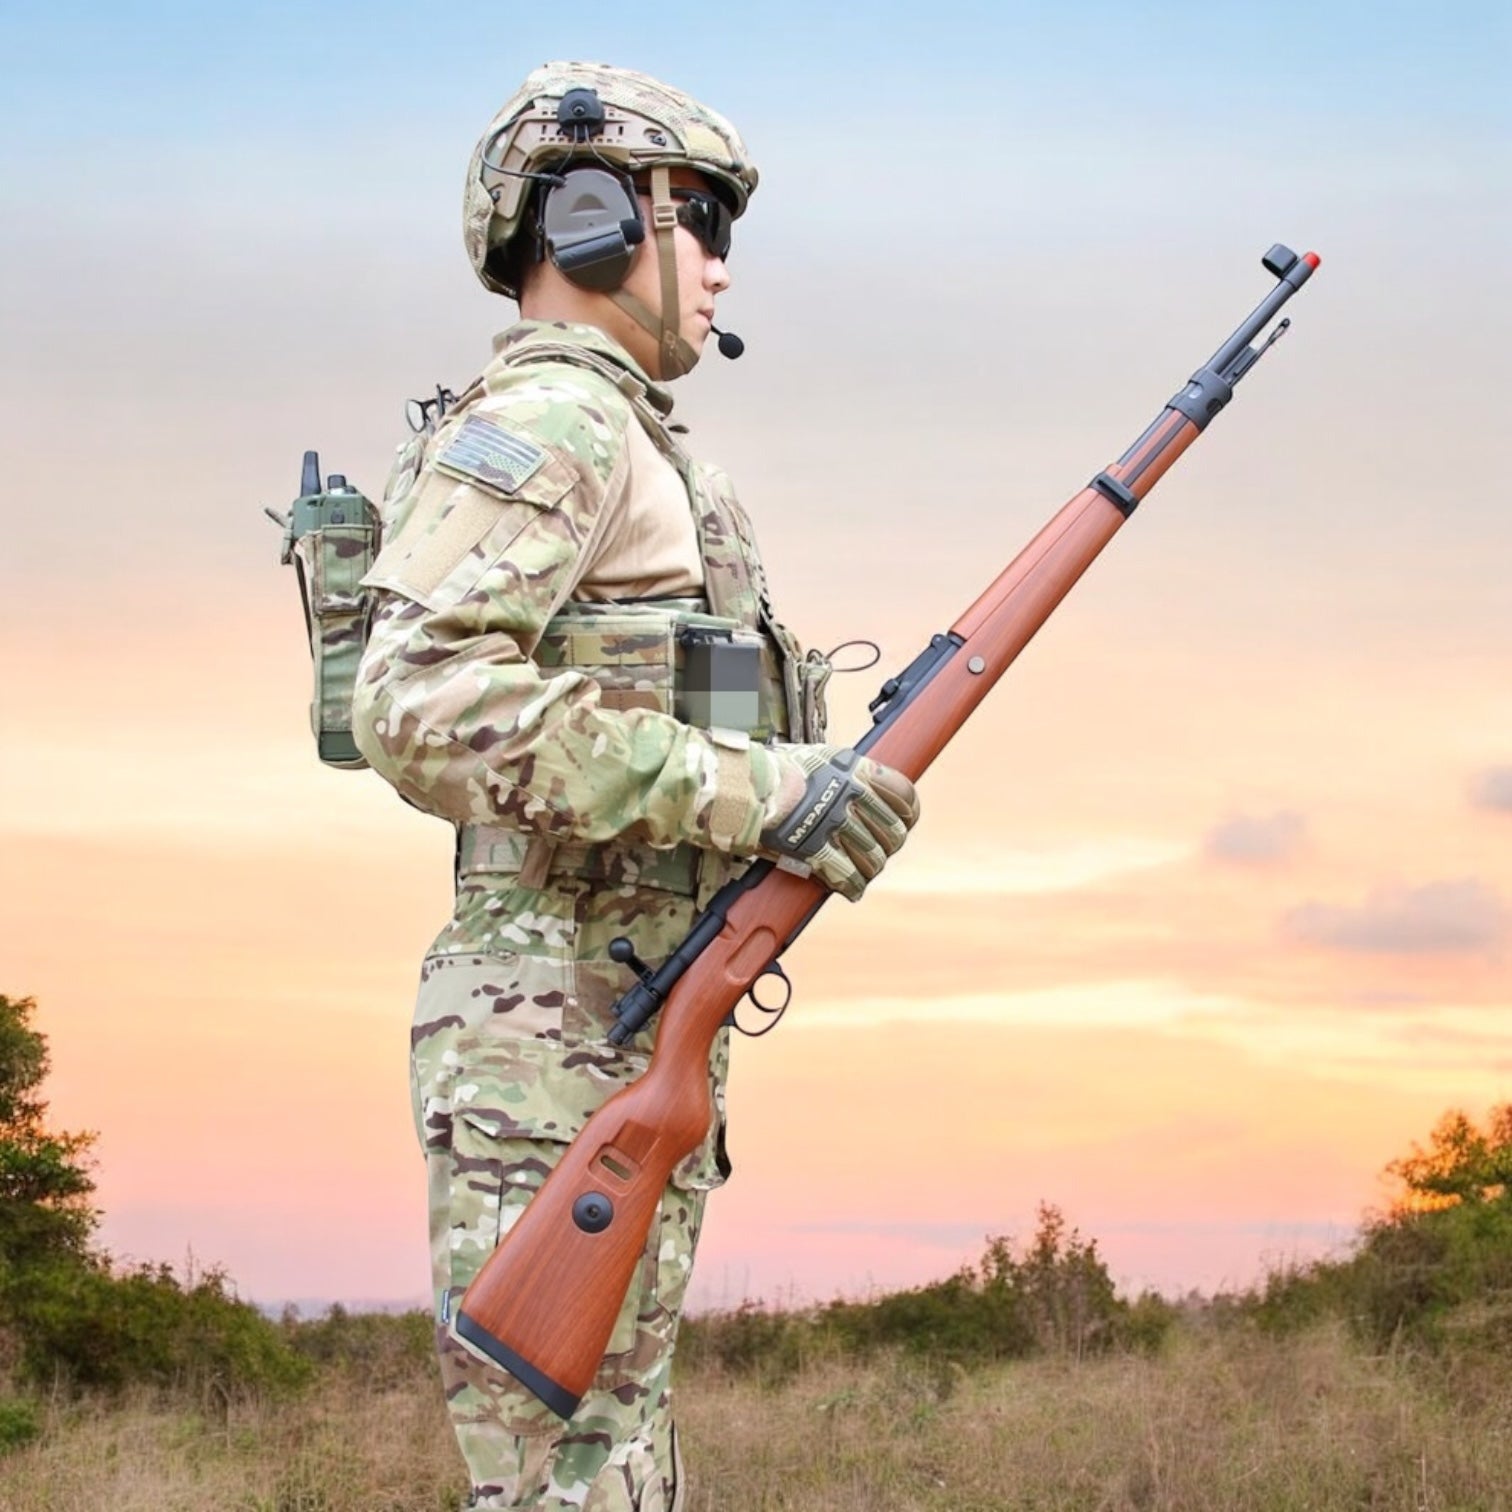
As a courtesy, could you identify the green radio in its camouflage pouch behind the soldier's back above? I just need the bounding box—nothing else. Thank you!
[268,452,380,771]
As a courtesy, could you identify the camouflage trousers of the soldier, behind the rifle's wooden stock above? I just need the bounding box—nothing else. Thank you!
[411,875,726,1512]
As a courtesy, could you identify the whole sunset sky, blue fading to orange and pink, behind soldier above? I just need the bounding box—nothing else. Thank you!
[0,0,1512,1306]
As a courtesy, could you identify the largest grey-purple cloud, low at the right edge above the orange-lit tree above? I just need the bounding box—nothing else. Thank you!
[1282,877,1512,956]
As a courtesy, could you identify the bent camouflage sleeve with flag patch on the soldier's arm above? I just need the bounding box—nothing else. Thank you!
[352,373,783,854]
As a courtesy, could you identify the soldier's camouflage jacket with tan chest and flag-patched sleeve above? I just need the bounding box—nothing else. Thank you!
[354,322,827,876]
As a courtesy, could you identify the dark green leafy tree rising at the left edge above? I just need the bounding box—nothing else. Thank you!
[0,995,98,1281]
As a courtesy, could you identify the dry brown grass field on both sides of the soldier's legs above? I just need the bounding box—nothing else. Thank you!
[0,1328,1512,1512]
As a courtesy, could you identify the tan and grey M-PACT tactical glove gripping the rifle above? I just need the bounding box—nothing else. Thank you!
[749,745,919,903]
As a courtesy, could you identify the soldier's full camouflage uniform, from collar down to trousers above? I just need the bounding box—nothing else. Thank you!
[354,312,827,1512]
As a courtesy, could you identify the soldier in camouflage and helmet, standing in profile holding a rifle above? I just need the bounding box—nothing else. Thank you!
[354,64,918,1512]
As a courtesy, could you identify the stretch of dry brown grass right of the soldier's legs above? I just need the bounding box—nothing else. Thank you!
[682,1329,1512,1512]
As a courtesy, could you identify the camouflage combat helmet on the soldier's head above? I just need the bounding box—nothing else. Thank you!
[463,62,758,299]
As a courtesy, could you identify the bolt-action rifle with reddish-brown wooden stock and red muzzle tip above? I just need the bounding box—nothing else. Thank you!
[455,245,1318,1418]
